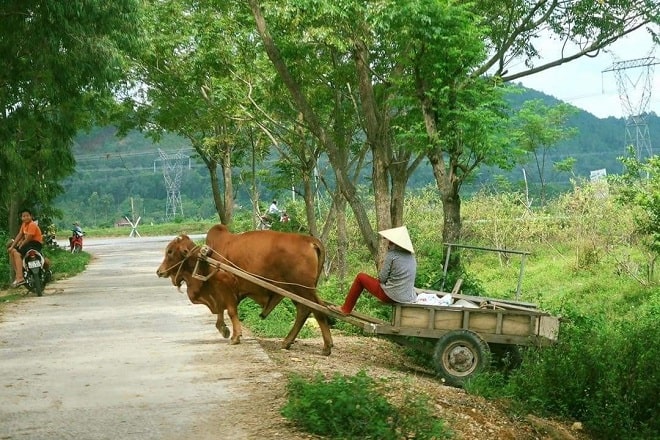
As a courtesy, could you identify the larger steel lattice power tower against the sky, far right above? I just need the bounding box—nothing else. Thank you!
[603,57,660,160]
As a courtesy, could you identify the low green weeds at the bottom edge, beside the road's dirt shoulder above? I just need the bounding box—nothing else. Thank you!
[282,371,450,440]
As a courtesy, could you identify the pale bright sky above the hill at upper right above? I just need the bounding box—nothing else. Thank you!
[509,29,660,118]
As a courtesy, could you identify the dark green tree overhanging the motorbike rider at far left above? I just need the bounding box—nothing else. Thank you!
[0,0,140,232]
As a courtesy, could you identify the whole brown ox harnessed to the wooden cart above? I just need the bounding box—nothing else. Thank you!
[157,225,332,355]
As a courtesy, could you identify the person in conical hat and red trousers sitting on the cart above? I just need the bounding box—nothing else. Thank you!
[329,226,417,315]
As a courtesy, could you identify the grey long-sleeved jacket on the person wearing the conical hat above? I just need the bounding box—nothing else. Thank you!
[378,247,417,303]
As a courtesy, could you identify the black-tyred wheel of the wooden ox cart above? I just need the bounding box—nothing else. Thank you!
[433,330,490,387]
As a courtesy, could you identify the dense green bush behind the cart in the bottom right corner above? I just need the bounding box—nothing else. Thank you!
[467,292,660,440]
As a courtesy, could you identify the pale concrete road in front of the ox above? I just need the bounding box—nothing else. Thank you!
[0,237,281,440]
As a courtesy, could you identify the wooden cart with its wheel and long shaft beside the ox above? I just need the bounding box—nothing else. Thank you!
[193,245,559,386]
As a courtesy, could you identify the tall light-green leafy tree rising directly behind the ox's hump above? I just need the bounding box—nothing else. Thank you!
[122,0,254,224]
